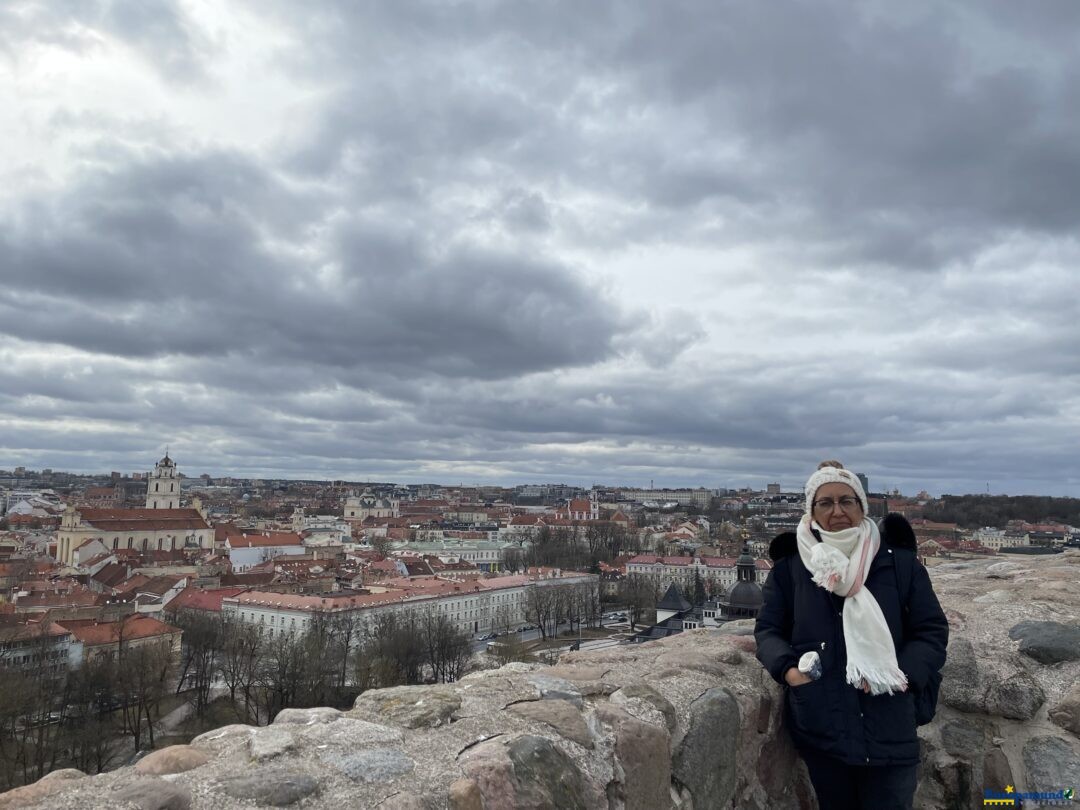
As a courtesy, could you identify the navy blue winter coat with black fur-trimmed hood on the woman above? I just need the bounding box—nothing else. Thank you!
[754,515,948,766]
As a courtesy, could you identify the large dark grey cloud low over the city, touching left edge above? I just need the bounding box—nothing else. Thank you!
[0,149,624,378]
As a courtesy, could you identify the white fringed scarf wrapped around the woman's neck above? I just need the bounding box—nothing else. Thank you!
[796,515,907,694]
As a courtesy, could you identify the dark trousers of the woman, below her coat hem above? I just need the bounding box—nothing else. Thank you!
[799,751,919,810]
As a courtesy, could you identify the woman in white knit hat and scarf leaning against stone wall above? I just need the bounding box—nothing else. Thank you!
[754,461,948,810]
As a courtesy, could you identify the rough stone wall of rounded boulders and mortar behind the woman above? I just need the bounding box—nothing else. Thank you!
[0,553,1080,810]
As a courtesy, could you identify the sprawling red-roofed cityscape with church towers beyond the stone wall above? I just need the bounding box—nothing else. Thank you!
[0,453,1080,807]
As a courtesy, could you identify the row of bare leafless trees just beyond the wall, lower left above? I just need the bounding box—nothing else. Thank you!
[0,610,472,791]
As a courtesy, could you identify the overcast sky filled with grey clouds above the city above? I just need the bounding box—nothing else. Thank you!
[0,0,1080,496]
